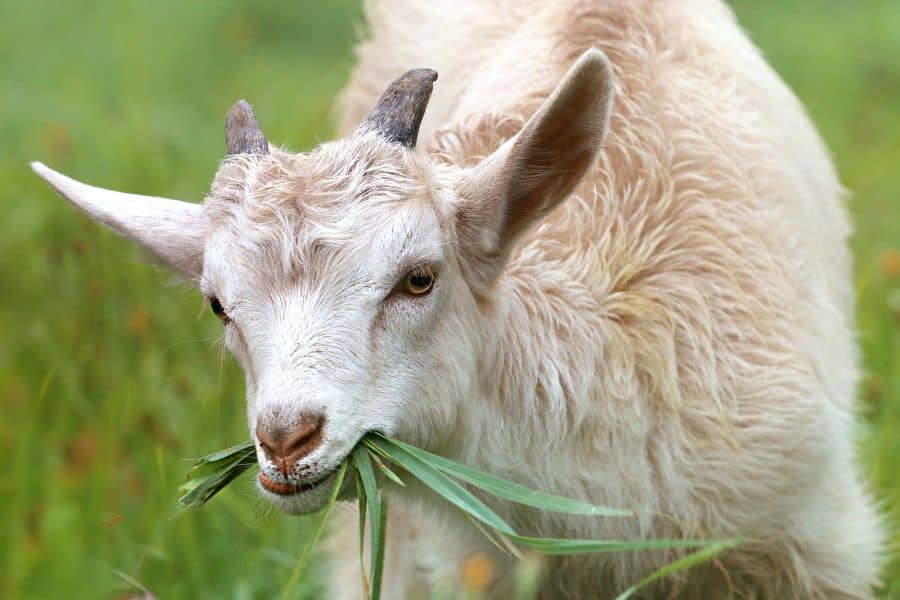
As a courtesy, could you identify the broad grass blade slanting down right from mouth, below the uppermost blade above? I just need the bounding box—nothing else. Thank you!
[363,437,515,535]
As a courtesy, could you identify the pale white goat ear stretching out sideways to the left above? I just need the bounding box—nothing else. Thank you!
[31,162,207,279]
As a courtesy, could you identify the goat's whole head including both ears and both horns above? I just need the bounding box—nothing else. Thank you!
[33,50,612,513]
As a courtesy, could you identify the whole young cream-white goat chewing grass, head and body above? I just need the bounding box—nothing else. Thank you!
[34,0,881,598]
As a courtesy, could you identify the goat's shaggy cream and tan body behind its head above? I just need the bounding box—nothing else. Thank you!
[330,0,881,598]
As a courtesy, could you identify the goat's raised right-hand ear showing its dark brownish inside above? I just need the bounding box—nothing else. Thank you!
[458,49,613,279]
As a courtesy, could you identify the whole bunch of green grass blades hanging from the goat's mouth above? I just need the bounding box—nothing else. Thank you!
[178,434,740,600]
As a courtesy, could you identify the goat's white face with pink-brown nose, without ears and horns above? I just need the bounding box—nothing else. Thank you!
[200,134,477,512]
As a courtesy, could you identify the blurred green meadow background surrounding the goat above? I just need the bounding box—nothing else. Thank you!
[0,0,900,598]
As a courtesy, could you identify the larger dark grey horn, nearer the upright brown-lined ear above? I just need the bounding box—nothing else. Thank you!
[360,69,437,148]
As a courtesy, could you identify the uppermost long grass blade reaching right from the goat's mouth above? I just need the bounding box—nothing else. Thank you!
[382,437,634,517]
